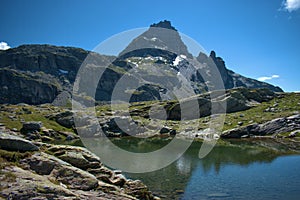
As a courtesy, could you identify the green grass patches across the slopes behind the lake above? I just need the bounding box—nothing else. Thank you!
[0,93,300,146]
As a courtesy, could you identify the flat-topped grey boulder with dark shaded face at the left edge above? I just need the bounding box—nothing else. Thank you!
[0,133,39,152]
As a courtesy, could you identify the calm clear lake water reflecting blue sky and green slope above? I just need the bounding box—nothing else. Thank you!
[84,138,300,199]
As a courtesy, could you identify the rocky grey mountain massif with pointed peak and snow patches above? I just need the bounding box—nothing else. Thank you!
[0,20,282,105]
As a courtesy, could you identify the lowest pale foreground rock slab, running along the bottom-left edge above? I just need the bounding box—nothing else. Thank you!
[0,166,135,200]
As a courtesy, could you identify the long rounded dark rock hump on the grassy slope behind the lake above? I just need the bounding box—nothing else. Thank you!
[166,88,276,120]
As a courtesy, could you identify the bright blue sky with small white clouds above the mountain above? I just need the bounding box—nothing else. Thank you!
[0,0,300,91]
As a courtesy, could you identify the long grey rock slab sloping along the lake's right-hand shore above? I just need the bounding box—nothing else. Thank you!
[221,114,300,138]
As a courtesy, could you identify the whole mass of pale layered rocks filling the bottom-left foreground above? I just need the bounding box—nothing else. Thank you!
[0,125,159,200]
